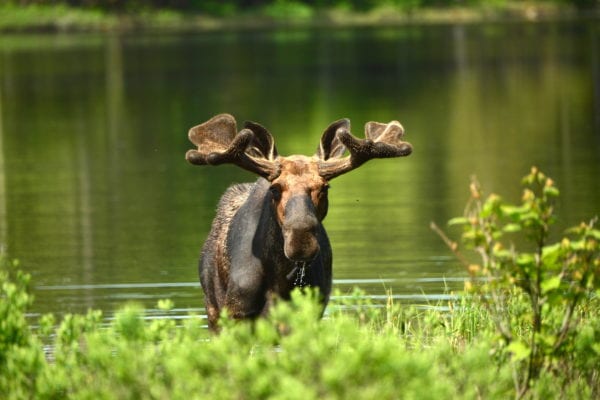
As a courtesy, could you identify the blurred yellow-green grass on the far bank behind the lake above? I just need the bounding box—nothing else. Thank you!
[0,0,576,32]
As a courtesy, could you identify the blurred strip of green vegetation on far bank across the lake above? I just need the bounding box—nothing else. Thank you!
[0,0,599,31]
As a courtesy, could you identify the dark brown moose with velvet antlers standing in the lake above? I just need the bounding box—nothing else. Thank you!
[185,114,412,332]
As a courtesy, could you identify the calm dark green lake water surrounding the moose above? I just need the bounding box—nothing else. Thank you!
[0,21,600,322]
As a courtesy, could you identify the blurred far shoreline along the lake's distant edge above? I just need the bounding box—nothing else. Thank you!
[0,2,600,33]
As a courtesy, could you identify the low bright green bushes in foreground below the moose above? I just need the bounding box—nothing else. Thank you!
[0,262,598,399]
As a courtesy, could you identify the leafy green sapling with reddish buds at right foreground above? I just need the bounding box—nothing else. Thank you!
[434,167,600,396]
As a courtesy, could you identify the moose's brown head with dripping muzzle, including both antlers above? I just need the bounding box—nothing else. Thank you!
[185,114,412,261]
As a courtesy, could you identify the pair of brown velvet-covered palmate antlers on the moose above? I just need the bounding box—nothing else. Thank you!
[185,114,412,181]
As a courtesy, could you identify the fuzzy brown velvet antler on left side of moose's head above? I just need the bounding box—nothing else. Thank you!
[185,114,279,180]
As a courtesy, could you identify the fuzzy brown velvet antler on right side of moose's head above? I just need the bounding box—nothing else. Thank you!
[319,120,412,180]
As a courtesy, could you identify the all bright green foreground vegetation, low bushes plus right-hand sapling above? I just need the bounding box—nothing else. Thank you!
[0,169,600,399]
